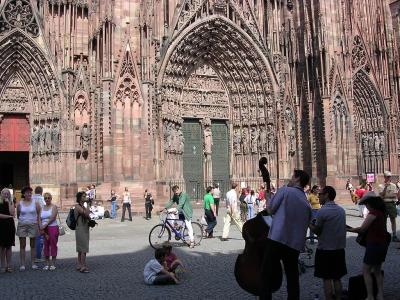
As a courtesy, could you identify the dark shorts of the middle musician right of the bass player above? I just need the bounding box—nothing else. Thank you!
[314,249,347,280]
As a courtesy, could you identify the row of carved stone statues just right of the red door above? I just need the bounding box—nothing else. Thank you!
[31,119,60,155]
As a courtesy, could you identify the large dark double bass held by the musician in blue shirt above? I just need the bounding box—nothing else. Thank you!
[235,157,282,296]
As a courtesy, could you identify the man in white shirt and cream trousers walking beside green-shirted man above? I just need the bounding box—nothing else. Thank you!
[221,183,243,241]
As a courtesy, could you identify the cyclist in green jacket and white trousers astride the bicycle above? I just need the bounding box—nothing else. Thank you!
[165,185,194,248]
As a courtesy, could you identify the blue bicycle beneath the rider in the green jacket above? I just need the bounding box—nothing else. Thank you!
[149,211,203,249]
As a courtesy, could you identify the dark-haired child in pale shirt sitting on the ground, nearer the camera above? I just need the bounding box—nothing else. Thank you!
[143,248,179,285]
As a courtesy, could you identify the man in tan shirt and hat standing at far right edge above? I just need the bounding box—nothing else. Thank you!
[379,171,400,242]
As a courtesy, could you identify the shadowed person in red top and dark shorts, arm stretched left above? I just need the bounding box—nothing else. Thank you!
[348,192,390,300]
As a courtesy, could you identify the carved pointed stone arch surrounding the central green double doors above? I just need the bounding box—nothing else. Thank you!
[153,15,278,178]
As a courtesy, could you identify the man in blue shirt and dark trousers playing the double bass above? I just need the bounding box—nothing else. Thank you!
[260,170,311,300]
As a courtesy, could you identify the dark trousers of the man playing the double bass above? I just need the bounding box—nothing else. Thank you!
[260,239,300,300]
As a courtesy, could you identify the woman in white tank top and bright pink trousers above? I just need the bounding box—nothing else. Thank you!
[40,193,59,271]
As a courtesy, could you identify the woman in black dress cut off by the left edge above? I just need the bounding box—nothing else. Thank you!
[0,189,15,273]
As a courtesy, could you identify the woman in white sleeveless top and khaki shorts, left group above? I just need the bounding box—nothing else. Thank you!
[17,187,41,271]
